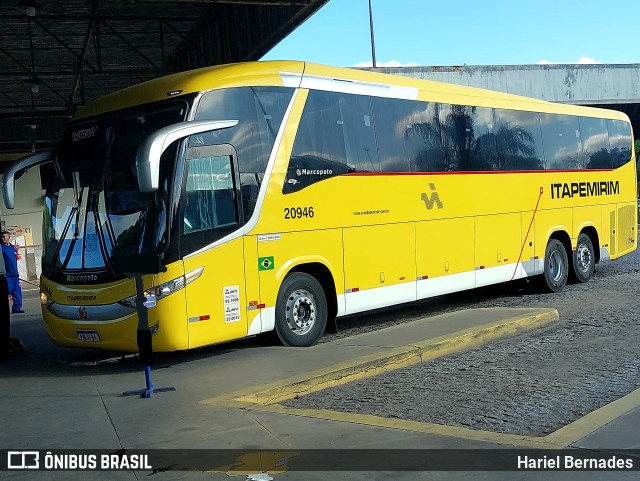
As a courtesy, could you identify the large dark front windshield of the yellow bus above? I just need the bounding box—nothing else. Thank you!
[43,101,188,283]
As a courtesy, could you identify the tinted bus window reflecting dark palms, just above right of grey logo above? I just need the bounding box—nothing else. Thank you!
[439,105,498,171]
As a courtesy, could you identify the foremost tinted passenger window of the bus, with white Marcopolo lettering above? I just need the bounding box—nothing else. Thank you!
[282,90,347,194]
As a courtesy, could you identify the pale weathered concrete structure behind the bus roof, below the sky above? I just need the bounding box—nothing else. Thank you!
[376,63,640,138]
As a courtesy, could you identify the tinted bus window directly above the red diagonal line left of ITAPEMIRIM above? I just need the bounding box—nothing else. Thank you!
[494,109,545,170]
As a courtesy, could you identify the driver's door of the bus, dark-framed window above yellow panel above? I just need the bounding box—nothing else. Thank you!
[180,142,247,348]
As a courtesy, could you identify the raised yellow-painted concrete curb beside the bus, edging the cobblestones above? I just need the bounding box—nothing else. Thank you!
[232,309,559,405]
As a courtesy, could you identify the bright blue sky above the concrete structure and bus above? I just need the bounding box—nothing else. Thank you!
[263,0,640,67]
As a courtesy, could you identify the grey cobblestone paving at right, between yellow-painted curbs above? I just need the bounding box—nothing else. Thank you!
[286,246,640,436]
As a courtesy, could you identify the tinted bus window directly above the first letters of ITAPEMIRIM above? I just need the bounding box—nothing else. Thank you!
[540,114,582,170]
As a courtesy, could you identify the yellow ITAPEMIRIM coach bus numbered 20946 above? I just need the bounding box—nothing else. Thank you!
[5,61,637,351]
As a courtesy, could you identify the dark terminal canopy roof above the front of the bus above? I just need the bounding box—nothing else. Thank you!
[0,0,328,160]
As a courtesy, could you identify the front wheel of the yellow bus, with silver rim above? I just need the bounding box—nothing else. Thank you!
[275,272,328,347]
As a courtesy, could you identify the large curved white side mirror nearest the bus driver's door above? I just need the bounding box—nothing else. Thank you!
[136,120,238,192]
